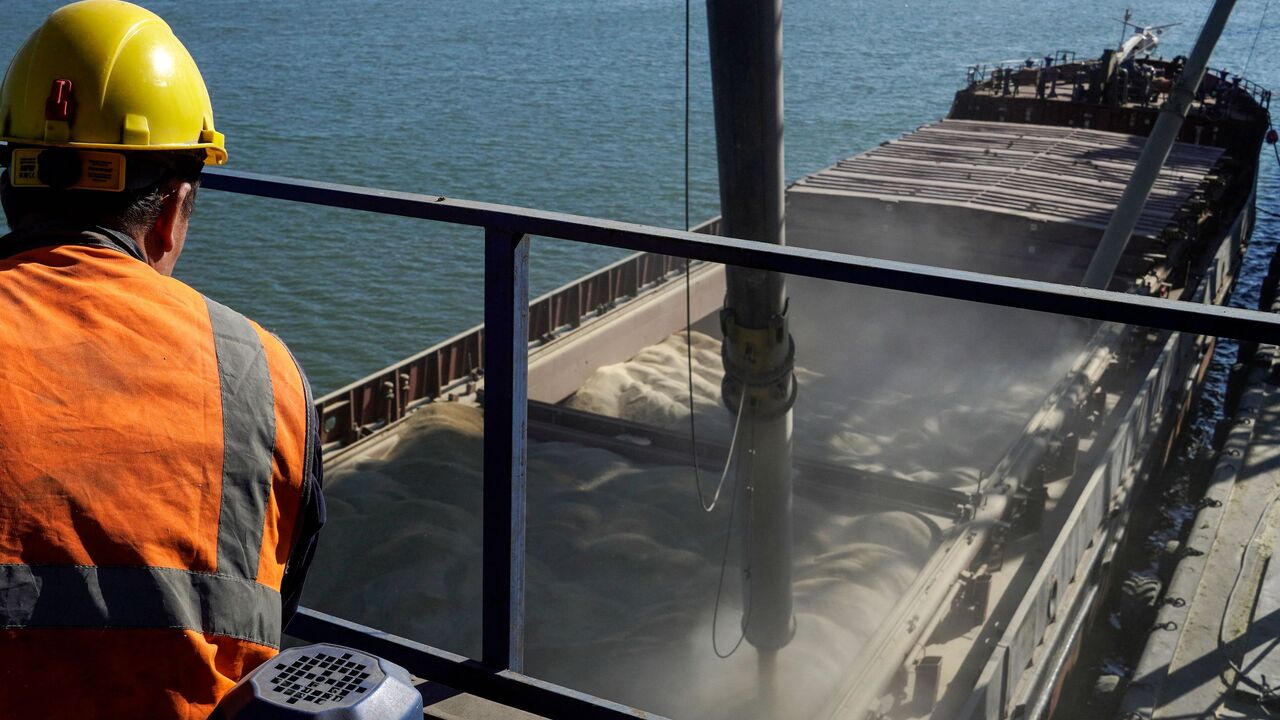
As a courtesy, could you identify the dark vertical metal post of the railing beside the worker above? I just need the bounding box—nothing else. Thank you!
[480,229,529,671]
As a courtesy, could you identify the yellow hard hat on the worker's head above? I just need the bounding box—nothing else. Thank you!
[0,0,227,165]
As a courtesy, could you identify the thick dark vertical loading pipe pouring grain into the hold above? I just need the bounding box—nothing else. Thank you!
[707,0,796,653]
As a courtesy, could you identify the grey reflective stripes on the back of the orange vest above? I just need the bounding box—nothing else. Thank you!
[0,292,282,647]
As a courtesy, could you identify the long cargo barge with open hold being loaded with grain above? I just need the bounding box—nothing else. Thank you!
[290,22,1270,720]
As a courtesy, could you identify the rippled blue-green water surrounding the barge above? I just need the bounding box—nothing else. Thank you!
[0,0,1280,392]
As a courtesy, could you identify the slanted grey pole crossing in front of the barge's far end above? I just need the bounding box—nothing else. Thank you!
[1080,0,1235,290]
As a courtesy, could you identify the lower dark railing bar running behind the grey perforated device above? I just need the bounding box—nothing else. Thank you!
[287,607,663,720]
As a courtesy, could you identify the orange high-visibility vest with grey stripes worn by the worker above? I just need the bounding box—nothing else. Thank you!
[0,222,312,720]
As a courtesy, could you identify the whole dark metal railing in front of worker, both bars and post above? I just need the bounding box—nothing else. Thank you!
[204,170,1280,719]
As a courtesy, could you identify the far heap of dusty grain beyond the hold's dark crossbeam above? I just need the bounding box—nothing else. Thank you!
[576,302,1084,489]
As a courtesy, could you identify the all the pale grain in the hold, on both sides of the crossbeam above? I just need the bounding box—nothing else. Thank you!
[305,237,1088,720]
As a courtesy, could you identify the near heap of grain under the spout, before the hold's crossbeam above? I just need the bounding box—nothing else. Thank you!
[305,394,936,719]
